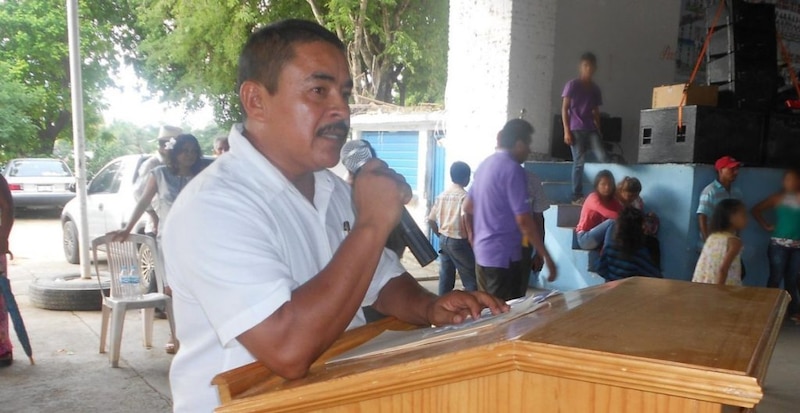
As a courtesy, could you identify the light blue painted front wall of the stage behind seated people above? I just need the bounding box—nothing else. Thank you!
[526,163,783,289]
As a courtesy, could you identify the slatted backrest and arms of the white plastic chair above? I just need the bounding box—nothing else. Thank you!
[92,234,164,298]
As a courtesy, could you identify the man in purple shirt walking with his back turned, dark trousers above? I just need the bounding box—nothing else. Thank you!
[464,119,557,300]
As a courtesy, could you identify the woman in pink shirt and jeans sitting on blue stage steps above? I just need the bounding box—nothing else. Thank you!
[575,170,622,250]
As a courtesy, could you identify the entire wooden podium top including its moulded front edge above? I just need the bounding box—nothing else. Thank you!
[214,277,788,412]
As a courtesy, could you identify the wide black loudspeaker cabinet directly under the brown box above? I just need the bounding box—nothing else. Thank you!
[638,106,765,165]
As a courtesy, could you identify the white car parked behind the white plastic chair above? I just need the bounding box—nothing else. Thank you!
[61,155,149,264]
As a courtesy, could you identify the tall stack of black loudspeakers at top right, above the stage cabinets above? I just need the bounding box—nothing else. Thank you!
[706,0,778,110]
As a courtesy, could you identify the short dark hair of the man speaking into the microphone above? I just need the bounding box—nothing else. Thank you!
[236,19,345,94]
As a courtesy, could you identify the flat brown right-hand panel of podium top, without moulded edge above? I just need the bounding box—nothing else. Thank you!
[520,278,783,374]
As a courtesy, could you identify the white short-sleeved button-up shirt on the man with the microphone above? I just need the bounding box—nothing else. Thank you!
[163,125,405,413]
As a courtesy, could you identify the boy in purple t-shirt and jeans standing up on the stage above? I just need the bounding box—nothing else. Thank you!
[561,52,606,205]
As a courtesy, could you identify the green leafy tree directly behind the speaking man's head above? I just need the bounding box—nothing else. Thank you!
[128,0,448,126]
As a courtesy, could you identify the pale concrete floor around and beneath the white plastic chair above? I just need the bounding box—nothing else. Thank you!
[0,216,800,413]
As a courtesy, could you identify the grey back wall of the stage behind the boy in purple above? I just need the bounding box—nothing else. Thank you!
[552,0,681,160]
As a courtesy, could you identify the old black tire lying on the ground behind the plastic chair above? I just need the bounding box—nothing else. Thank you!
[28,274,110,311]
